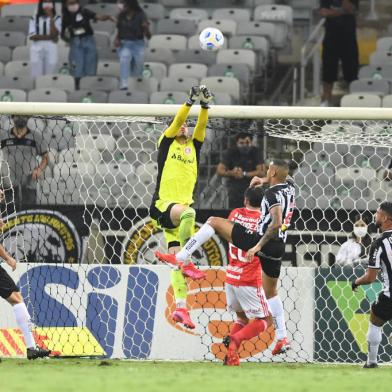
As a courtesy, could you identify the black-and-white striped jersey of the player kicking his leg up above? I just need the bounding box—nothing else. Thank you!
[257,182,295,242]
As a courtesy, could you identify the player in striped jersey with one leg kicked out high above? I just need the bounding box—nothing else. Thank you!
[156,159,295,355]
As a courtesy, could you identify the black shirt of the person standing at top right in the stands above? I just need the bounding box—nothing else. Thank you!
[320,0,359,38]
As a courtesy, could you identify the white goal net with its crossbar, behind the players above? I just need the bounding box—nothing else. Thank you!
[0,103,392,362]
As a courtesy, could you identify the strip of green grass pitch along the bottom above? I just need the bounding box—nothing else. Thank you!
[0,359,392,392]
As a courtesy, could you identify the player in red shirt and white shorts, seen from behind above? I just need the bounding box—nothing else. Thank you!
[223,187,272,366]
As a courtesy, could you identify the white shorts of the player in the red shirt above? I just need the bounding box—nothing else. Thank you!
[225,283,271,319]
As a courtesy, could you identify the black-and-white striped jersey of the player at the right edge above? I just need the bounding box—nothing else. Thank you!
[368,230,392,298]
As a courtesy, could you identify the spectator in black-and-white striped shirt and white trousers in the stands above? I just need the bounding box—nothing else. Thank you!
[29,0,61,78]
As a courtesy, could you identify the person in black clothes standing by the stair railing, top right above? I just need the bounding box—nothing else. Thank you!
[320,0,359,106]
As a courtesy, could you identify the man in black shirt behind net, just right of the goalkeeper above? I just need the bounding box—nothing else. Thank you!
[216,132,265,209]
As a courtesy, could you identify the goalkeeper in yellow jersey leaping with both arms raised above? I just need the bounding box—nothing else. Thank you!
[150,86,213,329]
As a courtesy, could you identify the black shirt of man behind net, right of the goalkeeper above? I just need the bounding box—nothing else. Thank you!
[222,146,264,192]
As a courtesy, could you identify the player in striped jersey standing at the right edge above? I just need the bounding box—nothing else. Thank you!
[351,202,392,369]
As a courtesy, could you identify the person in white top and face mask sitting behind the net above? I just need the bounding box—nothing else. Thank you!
[335,217,371,267]
